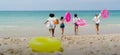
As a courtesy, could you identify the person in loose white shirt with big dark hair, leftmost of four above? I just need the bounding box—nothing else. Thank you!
[45,13,56,37]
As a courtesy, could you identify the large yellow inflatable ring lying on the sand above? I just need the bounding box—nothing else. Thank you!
[29,37,61,52]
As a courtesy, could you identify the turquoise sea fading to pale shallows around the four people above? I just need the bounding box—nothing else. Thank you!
[0,10,120,35]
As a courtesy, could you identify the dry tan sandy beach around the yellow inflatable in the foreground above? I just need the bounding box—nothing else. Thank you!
[0,34,120,55]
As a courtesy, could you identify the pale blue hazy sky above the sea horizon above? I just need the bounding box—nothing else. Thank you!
[0,0,120,11]
